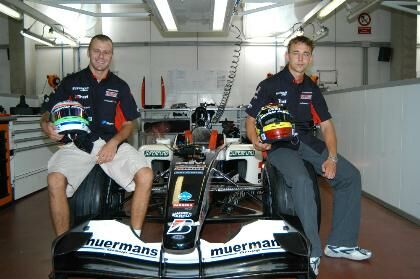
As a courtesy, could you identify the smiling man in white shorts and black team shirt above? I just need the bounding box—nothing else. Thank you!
[41,35,153,236]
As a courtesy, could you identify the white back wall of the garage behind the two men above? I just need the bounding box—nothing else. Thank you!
[22,3,391,110]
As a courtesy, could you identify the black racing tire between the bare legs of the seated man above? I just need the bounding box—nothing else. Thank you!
[69,165,125,226]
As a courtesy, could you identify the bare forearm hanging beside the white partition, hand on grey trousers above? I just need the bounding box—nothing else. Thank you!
[320,119,338,179]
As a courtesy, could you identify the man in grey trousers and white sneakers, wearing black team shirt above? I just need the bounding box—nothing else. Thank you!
[246,36,372,275]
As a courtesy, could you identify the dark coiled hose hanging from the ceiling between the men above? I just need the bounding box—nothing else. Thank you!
[211,24,242,124]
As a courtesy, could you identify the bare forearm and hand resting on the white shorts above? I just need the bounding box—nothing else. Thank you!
[97,121,134,164]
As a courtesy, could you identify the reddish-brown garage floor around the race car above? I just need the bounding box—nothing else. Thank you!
[0,180,420,279]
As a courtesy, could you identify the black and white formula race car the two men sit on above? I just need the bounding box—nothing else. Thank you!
[51,127,319,278]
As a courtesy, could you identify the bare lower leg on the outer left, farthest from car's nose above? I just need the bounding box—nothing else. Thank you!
[48,172,70,236]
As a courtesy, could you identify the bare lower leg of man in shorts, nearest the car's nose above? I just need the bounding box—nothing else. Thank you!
[131,167,153,230]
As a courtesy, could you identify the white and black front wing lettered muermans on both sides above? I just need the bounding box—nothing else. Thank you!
[53,220,309,278]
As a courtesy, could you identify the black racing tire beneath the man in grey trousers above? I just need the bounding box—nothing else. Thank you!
[262,161,321,230]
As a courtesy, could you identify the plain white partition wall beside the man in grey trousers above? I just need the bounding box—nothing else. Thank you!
[325,79,420,221]
